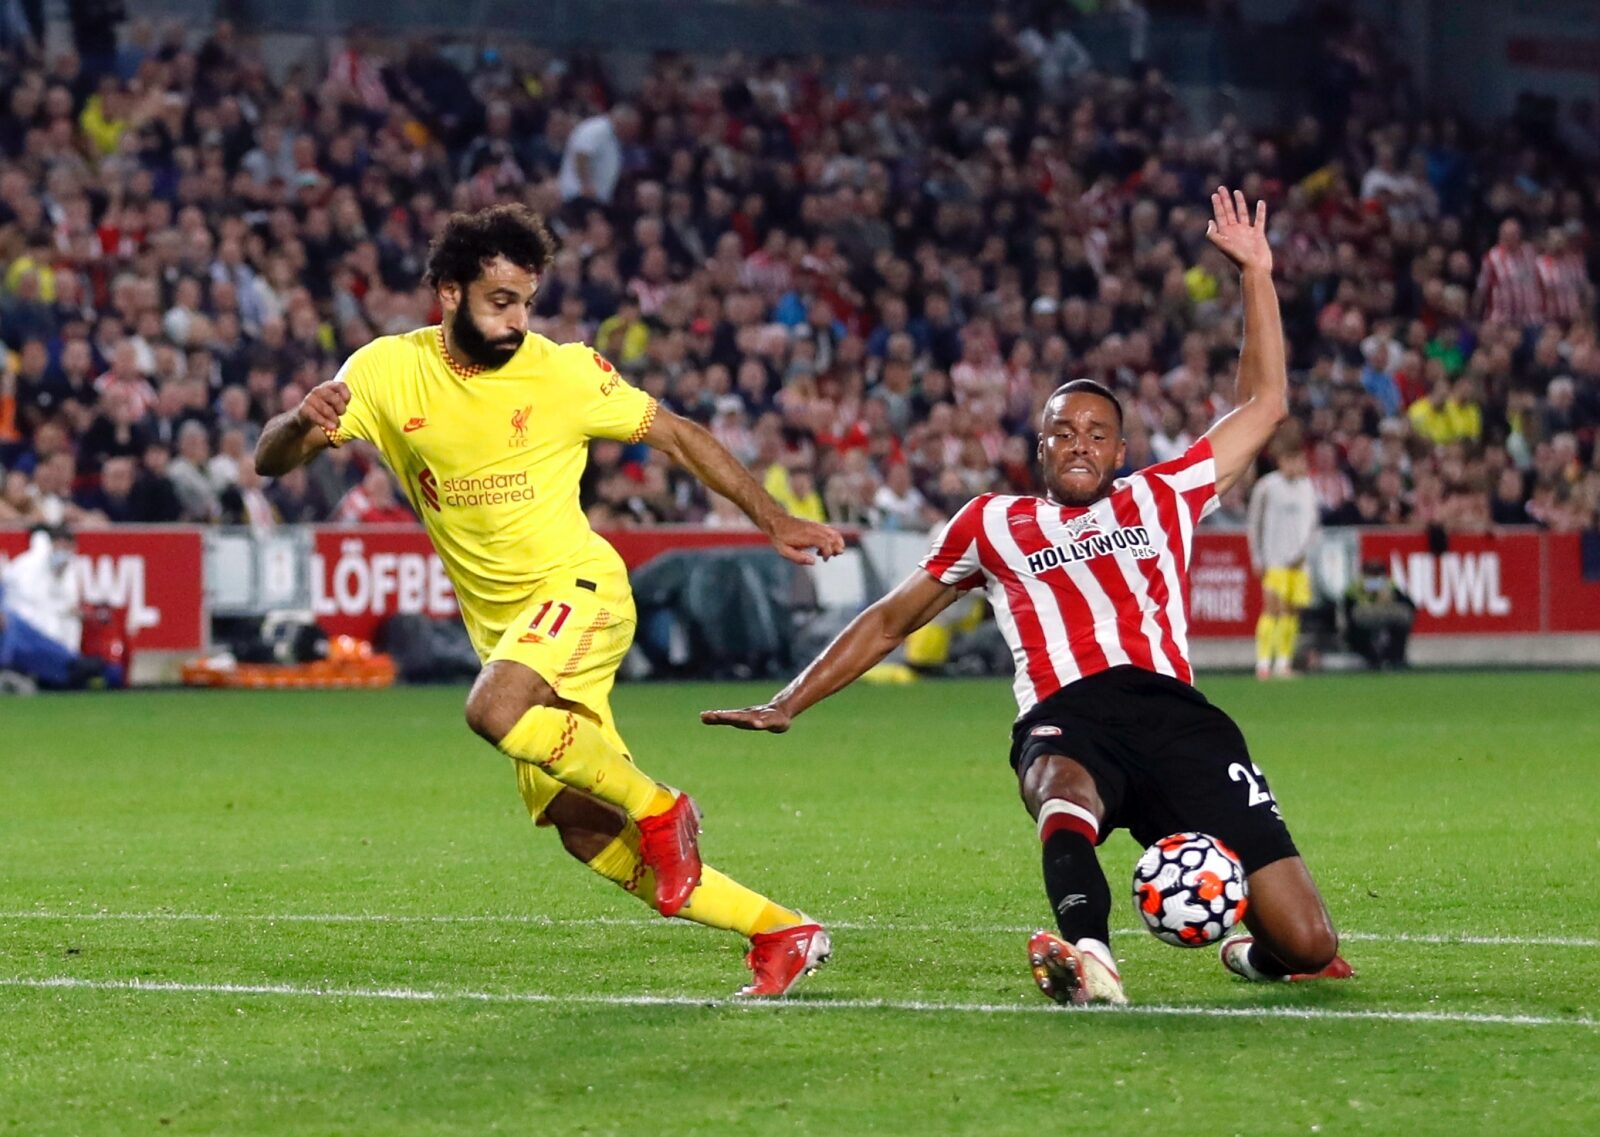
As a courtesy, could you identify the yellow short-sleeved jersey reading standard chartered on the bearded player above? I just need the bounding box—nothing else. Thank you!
[330,326,656,628]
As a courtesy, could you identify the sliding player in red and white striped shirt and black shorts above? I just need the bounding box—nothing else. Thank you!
[701,187,1350,1003]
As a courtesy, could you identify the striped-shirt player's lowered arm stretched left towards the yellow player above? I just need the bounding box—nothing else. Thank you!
[701,569,962,734]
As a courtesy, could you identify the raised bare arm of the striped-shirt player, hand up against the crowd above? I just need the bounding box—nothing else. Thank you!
[1206,186,1290,494]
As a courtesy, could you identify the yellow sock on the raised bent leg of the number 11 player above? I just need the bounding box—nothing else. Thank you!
[499,707,674,819]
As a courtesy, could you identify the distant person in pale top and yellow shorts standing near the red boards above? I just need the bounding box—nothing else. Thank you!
[1246,432,1322,680]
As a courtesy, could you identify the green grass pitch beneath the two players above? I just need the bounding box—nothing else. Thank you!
[0,673,1600,1137]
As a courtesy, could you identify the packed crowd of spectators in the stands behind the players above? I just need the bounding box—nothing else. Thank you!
[0,4,1600,533]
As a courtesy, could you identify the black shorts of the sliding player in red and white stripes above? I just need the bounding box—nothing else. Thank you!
[1011,667,1299,873]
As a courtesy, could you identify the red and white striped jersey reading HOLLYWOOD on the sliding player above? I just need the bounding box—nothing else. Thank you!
[922,438,1218,715]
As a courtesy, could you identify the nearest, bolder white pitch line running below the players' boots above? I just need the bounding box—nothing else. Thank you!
[0,975,1600,1030]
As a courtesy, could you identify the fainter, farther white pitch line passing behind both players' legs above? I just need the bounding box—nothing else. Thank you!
[0,912,1600,948]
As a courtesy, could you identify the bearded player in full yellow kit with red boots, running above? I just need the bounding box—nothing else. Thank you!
[256,205,843,995]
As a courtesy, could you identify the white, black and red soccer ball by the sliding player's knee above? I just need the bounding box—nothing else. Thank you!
[1133,833,1250,947]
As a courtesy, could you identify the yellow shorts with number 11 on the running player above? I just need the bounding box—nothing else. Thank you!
[462,569,637,820]
